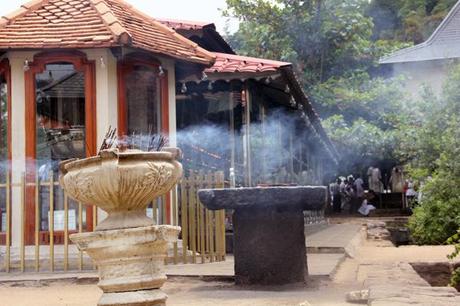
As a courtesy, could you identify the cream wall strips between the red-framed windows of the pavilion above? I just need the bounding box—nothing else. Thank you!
[6,49,176,246]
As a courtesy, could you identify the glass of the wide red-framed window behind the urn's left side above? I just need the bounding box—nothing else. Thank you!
[35,63,87,231]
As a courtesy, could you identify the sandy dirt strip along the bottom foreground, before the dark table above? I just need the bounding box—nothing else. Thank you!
[0,278,353,306]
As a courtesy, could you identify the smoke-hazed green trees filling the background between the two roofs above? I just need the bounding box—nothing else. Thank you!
[225,0,456,172]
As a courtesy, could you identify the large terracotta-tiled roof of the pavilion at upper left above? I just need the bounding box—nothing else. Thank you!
[0,0,214,65]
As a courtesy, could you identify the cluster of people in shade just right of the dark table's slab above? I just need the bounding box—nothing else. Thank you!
[331,175,375,216]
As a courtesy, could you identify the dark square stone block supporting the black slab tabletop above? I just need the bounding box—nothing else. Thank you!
[233,207,308,285]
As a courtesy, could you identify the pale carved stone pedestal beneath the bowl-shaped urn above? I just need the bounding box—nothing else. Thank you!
[70,225,180,306]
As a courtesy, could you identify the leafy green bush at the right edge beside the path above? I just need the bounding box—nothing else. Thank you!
[404,65,460,244]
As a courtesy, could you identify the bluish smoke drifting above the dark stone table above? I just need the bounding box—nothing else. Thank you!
[177,109,321,185]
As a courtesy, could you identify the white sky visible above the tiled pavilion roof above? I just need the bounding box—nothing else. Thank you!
[0,0,238,33]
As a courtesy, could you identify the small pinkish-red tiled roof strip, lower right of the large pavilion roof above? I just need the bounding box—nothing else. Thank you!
[205,52,292,73]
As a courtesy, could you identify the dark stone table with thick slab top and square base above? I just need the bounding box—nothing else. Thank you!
[198,187,327,285]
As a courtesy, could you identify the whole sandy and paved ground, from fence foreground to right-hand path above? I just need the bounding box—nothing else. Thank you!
[0,218,460,306]
